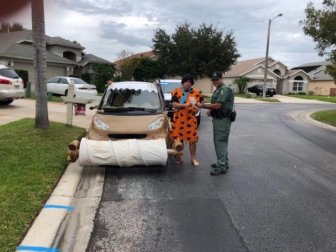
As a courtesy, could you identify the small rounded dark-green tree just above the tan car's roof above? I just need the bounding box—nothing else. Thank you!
[133,57,162,81]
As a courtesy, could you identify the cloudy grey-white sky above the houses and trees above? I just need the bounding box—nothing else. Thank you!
[8,0,324,68]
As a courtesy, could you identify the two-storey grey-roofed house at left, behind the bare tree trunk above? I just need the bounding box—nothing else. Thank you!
[0,30,113,89]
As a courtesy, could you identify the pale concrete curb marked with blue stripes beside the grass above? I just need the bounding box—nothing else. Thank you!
[16,162,83,252]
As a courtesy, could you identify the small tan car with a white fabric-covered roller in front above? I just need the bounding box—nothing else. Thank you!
[79,81,177,167]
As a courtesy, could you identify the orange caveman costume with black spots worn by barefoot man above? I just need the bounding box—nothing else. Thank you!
[170,88,203,143]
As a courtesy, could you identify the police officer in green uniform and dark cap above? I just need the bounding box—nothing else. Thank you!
[197,72,234,176]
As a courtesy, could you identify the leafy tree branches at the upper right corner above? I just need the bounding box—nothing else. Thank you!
[300,0,336,82]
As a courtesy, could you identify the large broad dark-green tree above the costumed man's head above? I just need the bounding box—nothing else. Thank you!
[153,22,240,78]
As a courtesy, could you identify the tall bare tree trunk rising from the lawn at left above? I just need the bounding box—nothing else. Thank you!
[31,0,49,128]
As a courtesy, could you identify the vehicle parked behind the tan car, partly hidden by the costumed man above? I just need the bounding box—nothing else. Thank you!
[160,79,201,126]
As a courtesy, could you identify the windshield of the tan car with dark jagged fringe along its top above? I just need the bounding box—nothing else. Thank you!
[102,88,161,112]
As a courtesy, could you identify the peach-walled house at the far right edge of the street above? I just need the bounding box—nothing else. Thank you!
[292,61,336,96]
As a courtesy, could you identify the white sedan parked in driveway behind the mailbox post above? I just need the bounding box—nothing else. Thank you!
[47,76,97,99]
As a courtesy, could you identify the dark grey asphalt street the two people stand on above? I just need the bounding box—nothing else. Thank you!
[87,103,336,252]
